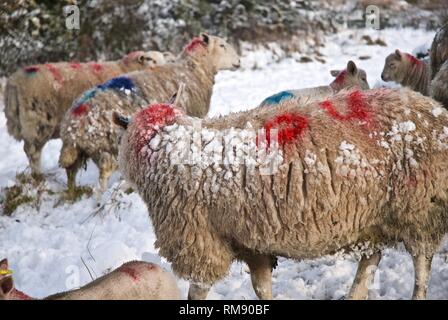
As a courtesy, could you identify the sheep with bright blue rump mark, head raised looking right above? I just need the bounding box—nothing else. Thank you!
[59,33,240,196]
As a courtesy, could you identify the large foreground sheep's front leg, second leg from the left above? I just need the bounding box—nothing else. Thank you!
[244,255,275,300]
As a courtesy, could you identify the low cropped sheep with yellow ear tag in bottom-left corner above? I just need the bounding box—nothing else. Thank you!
[0,259,180,300]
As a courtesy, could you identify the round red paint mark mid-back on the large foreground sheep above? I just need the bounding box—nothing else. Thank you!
[262,113,308,147]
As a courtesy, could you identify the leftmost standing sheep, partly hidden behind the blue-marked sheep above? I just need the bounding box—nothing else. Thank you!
[5,51,169,176]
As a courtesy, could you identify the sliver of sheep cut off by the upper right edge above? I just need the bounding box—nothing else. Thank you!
[429,23,448,109]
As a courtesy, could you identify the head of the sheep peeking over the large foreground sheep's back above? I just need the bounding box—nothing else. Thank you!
[330,61,370,91]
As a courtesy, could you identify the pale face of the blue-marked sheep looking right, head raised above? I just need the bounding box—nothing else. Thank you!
[200,33,240,70]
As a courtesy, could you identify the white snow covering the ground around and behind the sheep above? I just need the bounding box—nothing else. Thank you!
[0,29,448,299]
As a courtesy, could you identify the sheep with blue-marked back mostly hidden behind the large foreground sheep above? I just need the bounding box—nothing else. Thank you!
[260,60,369,106]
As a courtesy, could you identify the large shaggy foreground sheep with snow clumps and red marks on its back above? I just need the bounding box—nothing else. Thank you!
[114,88,448,299]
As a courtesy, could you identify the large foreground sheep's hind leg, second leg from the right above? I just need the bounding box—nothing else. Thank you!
[348,252,381,300]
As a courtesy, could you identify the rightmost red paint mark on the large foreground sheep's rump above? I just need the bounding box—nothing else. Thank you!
[319,90,371,123]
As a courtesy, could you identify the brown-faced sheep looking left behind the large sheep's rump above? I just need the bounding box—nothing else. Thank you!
[381,49,430,96]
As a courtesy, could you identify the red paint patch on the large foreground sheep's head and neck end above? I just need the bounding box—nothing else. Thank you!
[134,104,179,153]
